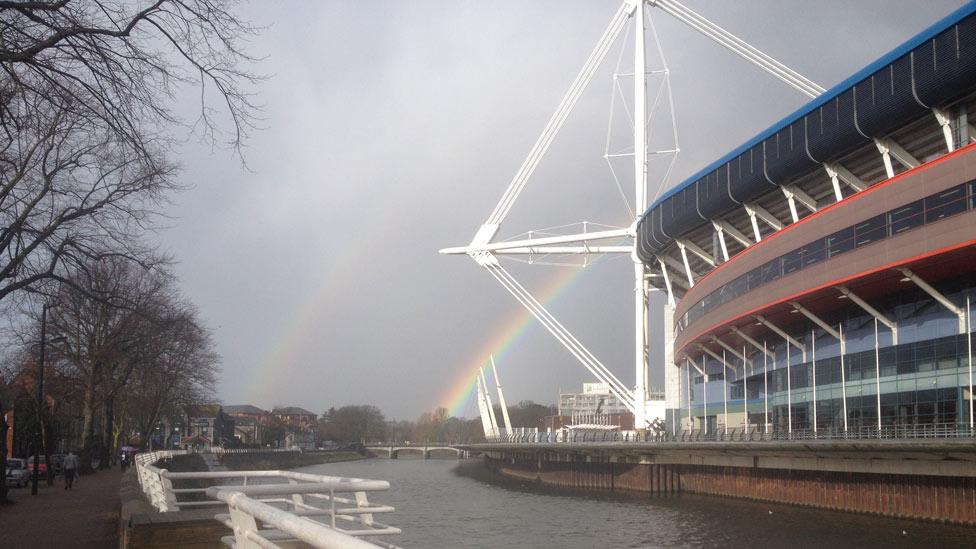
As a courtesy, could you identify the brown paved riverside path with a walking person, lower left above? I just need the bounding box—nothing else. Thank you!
[0,468,122,549]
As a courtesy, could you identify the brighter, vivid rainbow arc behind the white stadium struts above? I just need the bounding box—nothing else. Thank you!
[437,258,603,417]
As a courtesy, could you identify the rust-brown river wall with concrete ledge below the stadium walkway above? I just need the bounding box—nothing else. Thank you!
[472,441,976,525]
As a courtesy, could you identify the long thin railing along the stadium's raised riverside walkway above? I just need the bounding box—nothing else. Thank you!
[486,423,976,444]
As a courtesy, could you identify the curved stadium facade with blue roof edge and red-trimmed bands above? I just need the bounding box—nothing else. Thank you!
[638,4,976,434]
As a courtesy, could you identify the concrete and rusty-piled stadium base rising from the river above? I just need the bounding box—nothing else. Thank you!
[482,445,976,525]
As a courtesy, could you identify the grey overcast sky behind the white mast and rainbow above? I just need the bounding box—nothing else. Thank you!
[160,0,962,419]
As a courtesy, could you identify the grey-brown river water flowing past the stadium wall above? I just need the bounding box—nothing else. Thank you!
[301,458,976,549]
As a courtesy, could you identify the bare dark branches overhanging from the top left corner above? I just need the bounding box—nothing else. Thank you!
[0,0,256,152]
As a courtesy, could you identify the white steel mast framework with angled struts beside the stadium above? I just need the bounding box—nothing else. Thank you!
[440,0,824,433]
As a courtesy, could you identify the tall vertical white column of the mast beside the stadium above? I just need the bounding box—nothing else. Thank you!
[633,0,648,430]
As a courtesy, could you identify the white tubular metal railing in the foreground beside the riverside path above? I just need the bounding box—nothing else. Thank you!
[135,450,401,548]
